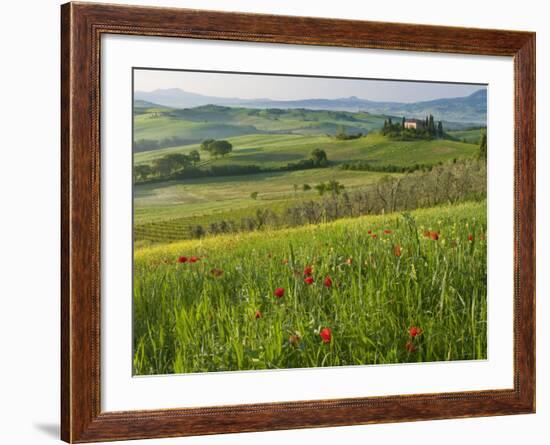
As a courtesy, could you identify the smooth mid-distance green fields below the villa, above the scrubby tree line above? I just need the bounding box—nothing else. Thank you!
[134,126,478,241]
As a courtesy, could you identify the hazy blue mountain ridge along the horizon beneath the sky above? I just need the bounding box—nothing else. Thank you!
[134,88,487,125]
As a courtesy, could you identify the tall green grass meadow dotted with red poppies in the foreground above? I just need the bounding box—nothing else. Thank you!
[133,202,487,375]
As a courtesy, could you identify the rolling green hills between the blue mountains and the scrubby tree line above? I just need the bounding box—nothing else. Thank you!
[134,99,488,240]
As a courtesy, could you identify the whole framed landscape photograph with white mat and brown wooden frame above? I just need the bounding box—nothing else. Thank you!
[61,3,535,443]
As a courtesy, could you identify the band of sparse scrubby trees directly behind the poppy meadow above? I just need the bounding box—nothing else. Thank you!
[176,159,487,238]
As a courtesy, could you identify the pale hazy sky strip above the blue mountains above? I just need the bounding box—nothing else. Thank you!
[134,70,485,102]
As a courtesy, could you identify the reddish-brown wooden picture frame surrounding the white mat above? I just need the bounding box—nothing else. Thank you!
[61,3,535,443]
